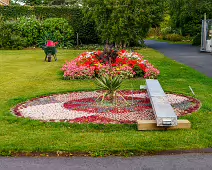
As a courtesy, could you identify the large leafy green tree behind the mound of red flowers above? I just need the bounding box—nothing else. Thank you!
[84,0,163,47]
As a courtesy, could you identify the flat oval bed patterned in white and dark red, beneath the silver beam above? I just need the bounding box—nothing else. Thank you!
[12,90,200,124]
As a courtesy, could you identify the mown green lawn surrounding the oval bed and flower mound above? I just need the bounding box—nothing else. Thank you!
[0,49,212,156]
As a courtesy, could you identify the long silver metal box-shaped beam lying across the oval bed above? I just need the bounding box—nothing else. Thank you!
[146,79,177,127]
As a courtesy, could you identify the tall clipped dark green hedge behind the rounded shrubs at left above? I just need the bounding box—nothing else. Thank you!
[0,6,99,44]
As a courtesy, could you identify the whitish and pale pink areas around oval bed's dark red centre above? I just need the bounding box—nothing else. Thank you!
[12,91,199,121]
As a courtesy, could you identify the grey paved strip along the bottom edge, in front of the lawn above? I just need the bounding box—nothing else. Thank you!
[0,154,212,170]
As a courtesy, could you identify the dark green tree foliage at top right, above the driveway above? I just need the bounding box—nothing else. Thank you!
[169,0,212,36]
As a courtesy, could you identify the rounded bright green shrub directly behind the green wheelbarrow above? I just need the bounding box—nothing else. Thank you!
[39,18,74,48]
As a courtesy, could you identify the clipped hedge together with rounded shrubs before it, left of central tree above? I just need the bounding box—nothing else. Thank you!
[0,6,99,49]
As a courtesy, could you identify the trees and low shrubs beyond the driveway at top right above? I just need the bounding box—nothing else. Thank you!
[149,0,212,45]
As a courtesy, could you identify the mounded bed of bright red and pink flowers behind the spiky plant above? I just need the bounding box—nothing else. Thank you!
[61,50,160,79]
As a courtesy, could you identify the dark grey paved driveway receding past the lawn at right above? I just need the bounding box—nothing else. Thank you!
[145,40,212,77]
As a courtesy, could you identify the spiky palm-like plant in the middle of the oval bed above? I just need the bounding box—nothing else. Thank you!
[96,75,122,104]
